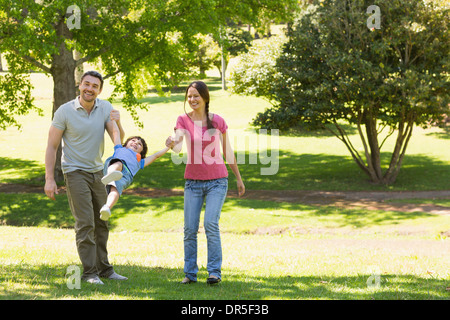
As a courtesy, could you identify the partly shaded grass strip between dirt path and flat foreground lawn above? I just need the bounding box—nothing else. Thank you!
[0,193,438,233]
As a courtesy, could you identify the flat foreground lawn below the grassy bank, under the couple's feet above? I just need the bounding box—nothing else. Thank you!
[0,227,450,300]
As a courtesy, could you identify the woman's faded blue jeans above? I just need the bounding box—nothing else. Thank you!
[184,178,228,281]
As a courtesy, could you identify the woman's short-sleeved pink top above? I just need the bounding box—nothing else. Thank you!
[175,114,228,180]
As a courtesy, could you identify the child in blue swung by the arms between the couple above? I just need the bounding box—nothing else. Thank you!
[100,136,170,221]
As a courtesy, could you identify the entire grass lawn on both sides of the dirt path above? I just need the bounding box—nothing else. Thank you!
[0,73,450,300]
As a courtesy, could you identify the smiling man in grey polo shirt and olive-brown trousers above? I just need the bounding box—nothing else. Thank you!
[44,71,127,284]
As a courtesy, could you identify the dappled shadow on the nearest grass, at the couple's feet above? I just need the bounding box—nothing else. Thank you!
[0,263,448,304]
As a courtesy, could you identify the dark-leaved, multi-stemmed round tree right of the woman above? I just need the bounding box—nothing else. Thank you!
[237,0,450,184]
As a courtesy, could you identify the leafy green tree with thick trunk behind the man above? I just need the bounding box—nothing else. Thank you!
[0,0,294,179]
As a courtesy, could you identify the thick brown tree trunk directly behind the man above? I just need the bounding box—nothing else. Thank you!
[50,21,76,182]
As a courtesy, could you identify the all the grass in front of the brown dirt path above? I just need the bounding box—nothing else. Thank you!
[0,194,450,300]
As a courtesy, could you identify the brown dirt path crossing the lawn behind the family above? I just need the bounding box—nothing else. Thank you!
[0,184,450,215]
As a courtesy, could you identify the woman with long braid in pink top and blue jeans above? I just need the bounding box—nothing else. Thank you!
[166,81,245,284]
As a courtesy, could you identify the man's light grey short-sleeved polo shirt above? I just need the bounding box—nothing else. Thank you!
[52,97,113,173]
